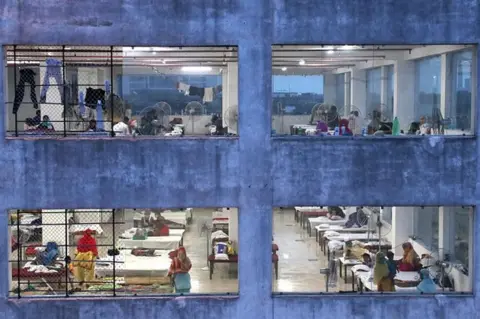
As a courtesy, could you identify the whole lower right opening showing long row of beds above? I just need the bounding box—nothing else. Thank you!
[273,206,473,294]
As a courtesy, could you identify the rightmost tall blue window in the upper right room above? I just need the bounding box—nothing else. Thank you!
[446,50,473,130]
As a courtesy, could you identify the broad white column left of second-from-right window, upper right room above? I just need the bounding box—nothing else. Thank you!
[393,60,419,132]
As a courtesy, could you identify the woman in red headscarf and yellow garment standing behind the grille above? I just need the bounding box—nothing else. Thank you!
[73,229,98,288]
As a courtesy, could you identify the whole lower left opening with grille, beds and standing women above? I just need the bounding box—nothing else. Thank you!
[9,208,239,298]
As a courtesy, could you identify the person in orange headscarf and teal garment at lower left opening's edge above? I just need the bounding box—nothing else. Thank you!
[168,247,192,293]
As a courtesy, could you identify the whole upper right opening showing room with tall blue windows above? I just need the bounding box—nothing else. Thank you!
[272,44,476,138]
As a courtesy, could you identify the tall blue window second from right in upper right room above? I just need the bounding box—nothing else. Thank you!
[412,56,442,123]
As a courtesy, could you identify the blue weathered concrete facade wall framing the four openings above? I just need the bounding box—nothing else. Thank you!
[0,0,480,319]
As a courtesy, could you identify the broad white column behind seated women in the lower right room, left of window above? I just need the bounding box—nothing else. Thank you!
[391,207,415,255]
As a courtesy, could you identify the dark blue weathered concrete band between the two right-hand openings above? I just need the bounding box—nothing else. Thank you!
[272,136,477,206]
